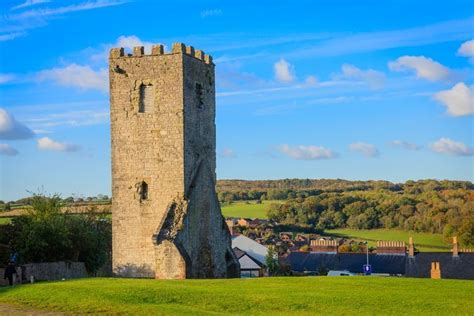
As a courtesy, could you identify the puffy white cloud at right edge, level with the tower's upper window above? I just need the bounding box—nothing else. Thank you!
[434,82,474,116]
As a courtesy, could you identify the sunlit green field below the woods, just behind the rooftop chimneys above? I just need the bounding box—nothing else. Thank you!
[325,229,450,251]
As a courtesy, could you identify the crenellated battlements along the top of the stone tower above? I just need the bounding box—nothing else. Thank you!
[109,43,213,65]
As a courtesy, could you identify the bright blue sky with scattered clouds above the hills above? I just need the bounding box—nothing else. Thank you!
[0,0,474,200]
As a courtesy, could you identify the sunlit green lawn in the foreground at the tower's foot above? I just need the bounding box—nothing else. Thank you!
[0,277,474,315]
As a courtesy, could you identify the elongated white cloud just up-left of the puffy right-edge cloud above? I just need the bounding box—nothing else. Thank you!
[388,56,453,81]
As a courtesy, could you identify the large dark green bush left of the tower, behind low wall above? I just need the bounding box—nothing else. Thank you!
[9,195,112,273]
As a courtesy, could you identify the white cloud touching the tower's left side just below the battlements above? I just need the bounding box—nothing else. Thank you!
[36,64,108,92]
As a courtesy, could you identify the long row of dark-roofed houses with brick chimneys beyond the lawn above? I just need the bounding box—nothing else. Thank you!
[285,238,474,280]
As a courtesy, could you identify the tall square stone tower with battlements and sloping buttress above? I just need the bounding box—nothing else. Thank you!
[109,43,240,279]
